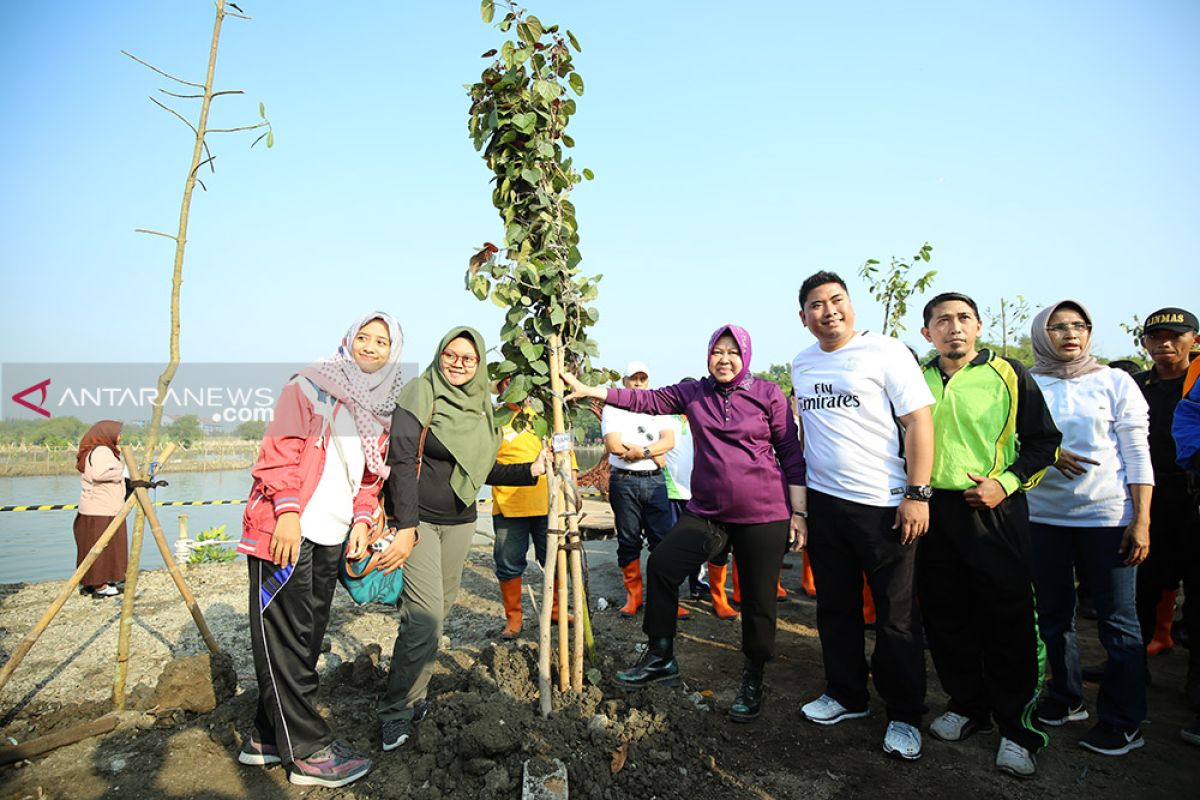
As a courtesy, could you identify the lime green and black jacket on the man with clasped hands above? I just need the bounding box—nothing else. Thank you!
[924,350,1062,494]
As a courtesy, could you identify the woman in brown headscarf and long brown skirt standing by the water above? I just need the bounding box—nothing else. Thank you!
[74,420,128,599]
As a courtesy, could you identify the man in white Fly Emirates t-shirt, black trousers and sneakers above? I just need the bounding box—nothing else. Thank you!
[792,272,934,760]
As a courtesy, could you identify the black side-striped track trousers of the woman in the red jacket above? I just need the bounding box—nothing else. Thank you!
[246,539,342,763]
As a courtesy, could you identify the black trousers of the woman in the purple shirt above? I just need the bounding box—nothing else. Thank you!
[642,511,788,664]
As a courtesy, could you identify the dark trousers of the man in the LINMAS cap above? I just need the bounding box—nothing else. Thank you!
[1138,485,1200,644]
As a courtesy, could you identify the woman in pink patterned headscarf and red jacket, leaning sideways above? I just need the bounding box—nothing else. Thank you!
[238,312,403,787]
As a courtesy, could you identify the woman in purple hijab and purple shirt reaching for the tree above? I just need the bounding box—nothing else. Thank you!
[564,325,805,722]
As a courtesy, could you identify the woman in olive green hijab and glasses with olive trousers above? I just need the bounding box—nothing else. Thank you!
[378,326,547,751]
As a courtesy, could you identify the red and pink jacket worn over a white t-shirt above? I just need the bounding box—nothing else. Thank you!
[238,378,388,560]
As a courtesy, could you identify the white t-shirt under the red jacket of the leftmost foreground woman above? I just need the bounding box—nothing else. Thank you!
[300,379,366,545]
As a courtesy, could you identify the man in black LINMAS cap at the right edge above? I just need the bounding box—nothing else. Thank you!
[1134,308,1200,678]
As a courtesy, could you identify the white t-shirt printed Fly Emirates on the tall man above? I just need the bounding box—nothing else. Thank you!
[792,331,934,506]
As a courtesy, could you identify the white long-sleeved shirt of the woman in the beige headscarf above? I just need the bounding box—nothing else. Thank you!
[1028,369,1154,528]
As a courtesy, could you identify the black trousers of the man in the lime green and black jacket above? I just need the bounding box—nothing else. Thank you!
[917,489,1049,752]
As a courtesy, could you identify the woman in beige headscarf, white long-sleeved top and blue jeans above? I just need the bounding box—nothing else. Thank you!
[1028,300,1154,756]
